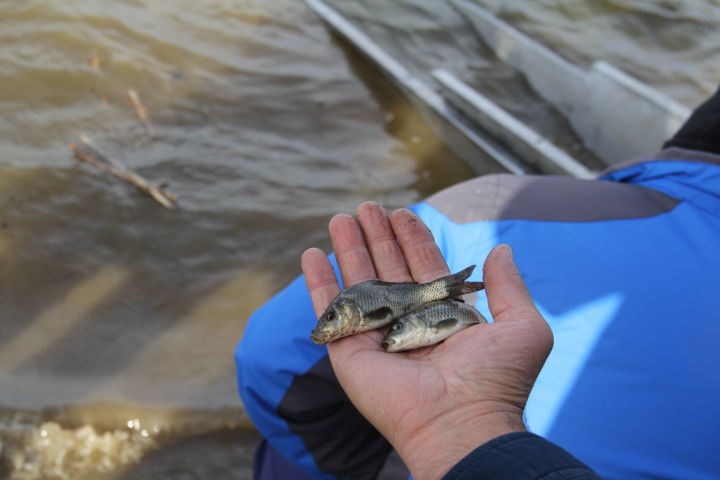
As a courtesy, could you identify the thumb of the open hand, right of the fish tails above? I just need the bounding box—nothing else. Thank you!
[483,245,542,322]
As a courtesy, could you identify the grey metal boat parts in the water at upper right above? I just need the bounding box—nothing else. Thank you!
[305,0,690,178]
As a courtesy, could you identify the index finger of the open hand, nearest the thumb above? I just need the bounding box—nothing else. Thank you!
[390,208,450,283]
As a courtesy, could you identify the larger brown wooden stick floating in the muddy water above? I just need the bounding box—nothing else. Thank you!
[69,134,178,209]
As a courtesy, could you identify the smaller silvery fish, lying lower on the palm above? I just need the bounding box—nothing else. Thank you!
[380,300,487,352]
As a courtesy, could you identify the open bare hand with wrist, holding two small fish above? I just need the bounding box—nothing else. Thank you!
[302,202,552,480]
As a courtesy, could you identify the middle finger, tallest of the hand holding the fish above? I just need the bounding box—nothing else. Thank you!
[357,202,412,282]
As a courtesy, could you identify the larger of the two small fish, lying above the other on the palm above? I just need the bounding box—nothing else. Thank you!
[310,265,484,345]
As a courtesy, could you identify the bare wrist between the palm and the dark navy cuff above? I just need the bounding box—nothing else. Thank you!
[393,408,526,480]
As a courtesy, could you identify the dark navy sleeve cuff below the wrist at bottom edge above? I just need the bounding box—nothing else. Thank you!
[442,432,601,480]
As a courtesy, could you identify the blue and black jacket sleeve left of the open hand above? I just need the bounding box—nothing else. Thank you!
[235,257,391,480]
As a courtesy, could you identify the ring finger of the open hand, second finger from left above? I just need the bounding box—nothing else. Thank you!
[328,213,377,287]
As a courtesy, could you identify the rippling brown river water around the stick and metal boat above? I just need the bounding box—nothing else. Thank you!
[0,0,720,480]
